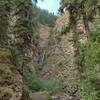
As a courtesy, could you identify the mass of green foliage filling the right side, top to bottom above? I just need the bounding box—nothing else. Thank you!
[61,0,100,100]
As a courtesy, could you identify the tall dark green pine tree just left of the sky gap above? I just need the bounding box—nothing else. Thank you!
[11,0,34,73]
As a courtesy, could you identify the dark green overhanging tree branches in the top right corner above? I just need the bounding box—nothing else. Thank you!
[60,0,100,35]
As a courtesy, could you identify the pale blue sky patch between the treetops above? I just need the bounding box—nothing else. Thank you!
[37,0,60,14]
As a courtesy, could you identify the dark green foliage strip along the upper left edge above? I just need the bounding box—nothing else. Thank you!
[0,0,10,43]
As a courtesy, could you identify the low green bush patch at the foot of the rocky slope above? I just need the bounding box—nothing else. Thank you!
[25,73,63,93]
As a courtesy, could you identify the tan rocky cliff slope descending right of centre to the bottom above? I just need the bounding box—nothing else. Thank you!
[40,12,78,100]
